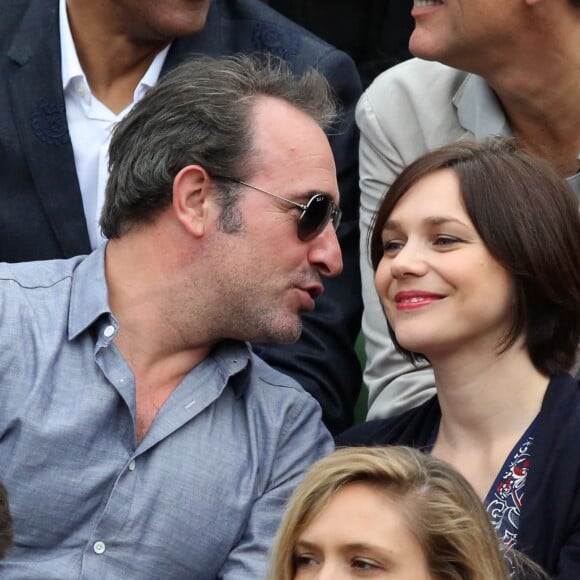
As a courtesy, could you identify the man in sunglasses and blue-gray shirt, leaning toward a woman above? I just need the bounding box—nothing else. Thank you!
[0,56,342,580]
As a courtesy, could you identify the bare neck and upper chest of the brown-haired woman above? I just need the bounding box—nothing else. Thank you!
[432,346,549,501]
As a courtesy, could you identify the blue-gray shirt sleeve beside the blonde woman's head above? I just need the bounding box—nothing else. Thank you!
[218,392,333,580]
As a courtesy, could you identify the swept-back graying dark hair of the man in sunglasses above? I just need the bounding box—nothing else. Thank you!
[100,55,337,238]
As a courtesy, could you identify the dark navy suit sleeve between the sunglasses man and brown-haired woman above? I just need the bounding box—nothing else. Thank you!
[256,47,362,434]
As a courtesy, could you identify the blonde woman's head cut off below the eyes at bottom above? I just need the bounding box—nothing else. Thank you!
[269,447,533,580]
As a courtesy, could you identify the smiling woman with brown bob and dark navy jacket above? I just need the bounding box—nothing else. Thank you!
[338,138,580,579]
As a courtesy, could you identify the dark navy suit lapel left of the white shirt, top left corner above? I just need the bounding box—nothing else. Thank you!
[8,0,90,256]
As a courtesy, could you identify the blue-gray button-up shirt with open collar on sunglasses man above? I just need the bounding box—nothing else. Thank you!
[0,248,332,580]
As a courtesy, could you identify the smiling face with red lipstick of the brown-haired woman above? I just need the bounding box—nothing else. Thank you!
[375,169,513,362]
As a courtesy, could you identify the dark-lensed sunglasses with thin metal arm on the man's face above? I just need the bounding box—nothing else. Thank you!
[213,175,342,242]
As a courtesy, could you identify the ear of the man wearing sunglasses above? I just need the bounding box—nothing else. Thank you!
[173,165,212,237]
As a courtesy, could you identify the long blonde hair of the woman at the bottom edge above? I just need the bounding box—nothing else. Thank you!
[268,446,524,580]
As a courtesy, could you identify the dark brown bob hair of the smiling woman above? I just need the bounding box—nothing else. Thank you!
[370,137,580,375]
